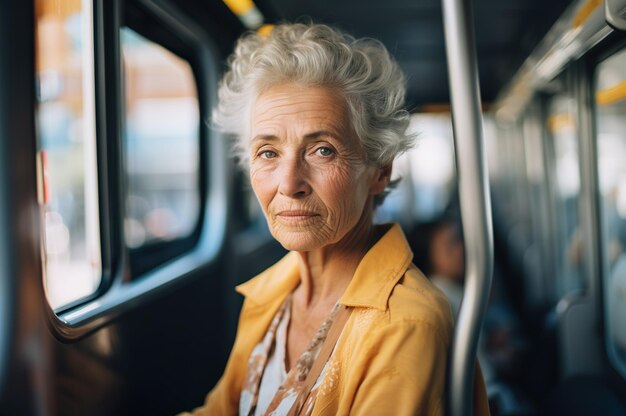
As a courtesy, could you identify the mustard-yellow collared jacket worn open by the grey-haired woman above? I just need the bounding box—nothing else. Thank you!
[183,225,489,416]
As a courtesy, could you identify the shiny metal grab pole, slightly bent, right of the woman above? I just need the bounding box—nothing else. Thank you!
[442,0,493,416]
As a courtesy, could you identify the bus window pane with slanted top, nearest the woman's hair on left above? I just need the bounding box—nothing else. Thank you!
[120,27,200,249]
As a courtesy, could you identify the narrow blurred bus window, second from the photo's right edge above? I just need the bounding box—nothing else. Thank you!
[546,93,584,299]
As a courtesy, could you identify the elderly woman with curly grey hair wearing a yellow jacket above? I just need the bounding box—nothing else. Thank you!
[183,24,487,415]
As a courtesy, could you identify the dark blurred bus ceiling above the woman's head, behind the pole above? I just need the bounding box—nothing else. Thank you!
[204,0,571,111]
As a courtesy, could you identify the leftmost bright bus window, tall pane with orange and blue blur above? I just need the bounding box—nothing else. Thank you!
[35,0,102,309]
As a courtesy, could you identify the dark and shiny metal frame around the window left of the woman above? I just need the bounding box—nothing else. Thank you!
[47,0,229,341]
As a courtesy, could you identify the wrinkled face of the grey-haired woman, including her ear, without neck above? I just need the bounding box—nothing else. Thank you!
[250,84,388,251]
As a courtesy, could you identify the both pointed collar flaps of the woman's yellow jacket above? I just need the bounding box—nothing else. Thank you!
[236,224,413,311]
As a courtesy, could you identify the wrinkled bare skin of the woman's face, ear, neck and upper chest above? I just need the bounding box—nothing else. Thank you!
[249,84,391,368]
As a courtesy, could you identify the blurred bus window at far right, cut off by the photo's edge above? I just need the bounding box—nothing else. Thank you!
[595,50,626,377]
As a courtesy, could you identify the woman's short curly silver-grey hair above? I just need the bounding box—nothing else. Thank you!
[213,23,414,200]
